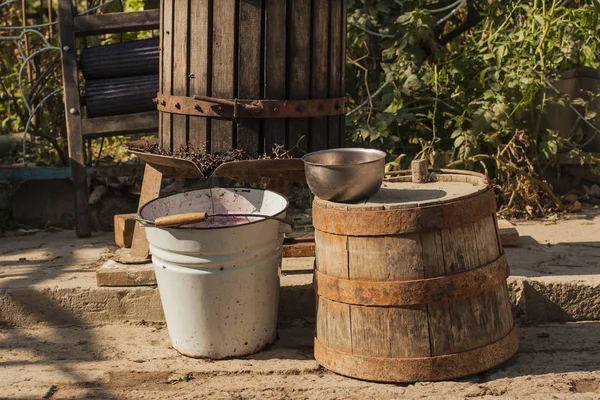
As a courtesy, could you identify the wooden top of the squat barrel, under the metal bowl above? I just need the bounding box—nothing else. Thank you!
[315,170,489,211]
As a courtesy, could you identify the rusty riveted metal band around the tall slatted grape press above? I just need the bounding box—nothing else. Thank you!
[154,93,346,119]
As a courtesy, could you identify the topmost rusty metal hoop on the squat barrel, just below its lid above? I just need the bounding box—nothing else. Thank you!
[313,189,496,236]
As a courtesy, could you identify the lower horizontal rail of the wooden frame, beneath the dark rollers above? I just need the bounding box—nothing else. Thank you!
[81,111,159,137]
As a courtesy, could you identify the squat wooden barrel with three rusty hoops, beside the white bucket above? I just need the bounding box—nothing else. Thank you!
[313,171,518,382]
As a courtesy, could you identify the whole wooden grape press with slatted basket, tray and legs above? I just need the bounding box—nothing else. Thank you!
[120,0,346,263]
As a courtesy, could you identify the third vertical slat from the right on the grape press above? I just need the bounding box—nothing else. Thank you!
[287,0,311,156]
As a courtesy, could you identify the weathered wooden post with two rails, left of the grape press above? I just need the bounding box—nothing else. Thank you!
[58,0,160,237]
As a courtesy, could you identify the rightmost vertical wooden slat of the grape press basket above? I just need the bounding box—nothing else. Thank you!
[327,0,346,148]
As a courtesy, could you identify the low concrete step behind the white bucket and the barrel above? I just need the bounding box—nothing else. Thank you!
[0,212,600,326]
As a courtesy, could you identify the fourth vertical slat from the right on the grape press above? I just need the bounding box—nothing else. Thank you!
[264,0,287,154]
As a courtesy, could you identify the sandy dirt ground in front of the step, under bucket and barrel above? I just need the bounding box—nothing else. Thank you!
[0,320,600,400]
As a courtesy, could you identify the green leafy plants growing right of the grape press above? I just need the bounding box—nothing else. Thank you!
[347,0,600,216]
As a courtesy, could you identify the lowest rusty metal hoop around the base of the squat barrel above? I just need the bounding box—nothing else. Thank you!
[315,326,519,382]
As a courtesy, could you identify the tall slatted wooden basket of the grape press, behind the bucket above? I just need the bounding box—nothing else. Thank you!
[158,0,346,157]
